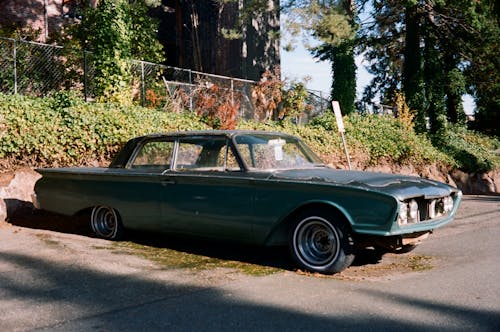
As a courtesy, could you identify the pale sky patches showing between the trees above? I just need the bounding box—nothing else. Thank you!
[281,43,474,114]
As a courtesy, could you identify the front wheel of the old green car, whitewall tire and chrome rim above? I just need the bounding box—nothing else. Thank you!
[289,209,355,274]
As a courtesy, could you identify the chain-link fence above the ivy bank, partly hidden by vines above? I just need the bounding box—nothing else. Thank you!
[0,37,328,123]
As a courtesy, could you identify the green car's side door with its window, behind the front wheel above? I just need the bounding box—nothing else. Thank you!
[162,136,254,242]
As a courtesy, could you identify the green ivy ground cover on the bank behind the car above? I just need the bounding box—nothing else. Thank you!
[0,92,500,172]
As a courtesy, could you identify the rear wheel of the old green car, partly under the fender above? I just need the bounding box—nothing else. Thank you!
[90,206,123,240]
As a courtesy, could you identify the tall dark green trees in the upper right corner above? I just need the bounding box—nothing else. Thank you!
[359,0,500,135]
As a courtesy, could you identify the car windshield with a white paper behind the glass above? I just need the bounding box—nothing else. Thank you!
[234,134,323,170]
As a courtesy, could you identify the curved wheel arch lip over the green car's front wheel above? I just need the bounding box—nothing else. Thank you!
[264,201,353,246]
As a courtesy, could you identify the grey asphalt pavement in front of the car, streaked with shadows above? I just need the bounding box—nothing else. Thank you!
[0,196,500,331]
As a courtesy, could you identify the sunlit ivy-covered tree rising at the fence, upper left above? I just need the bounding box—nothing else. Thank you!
[67,0,164,104]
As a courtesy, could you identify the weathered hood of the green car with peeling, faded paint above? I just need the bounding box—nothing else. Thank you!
[270,167,458,200]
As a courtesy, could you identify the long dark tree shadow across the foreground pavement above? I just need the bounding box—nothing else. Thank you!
[0,252,499,332]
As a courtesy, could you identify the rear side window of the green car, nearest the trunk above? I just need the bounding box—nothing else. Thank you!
[131,141,174,171]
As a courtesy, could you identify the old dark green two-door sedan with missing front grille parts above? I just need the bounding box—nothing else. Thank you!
[34,131,461,274]
